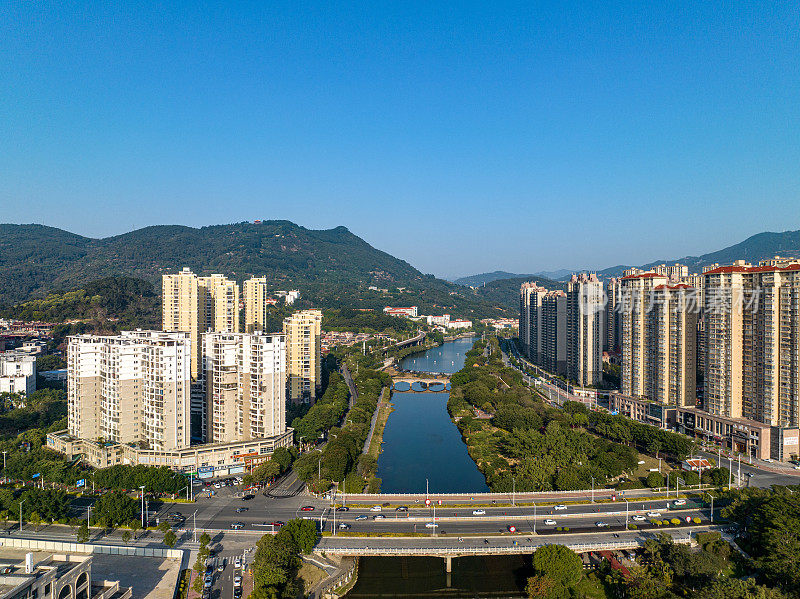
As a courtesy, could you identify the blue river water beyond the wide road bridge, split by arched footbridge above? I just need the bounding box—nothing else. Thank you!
[377,338,489,493]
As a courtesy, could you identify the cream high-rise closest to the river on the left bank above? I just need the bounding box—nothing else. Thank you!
[283,310,322,403]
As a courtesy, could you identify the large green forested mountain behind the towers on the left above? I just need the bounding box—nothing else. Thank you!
[0,221,504,318]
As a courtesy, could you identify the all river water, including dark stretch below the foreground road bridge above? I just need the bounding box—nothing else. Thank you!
[346,339,532,599]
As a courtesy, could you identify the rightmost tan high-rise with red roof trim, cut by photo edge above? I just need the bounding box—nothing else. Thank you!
[703,263,800,427]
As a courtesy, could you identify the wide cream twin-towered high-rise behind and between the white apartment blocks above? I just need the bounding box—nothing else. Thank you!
[162,268,239,440]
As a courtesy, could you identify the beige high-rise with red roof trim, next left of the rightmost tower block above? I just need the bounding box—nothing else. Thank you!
[618,272,699,406]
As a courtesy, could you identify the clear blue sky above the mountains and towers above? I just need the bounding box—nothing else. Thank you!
[0,1,800,276]
